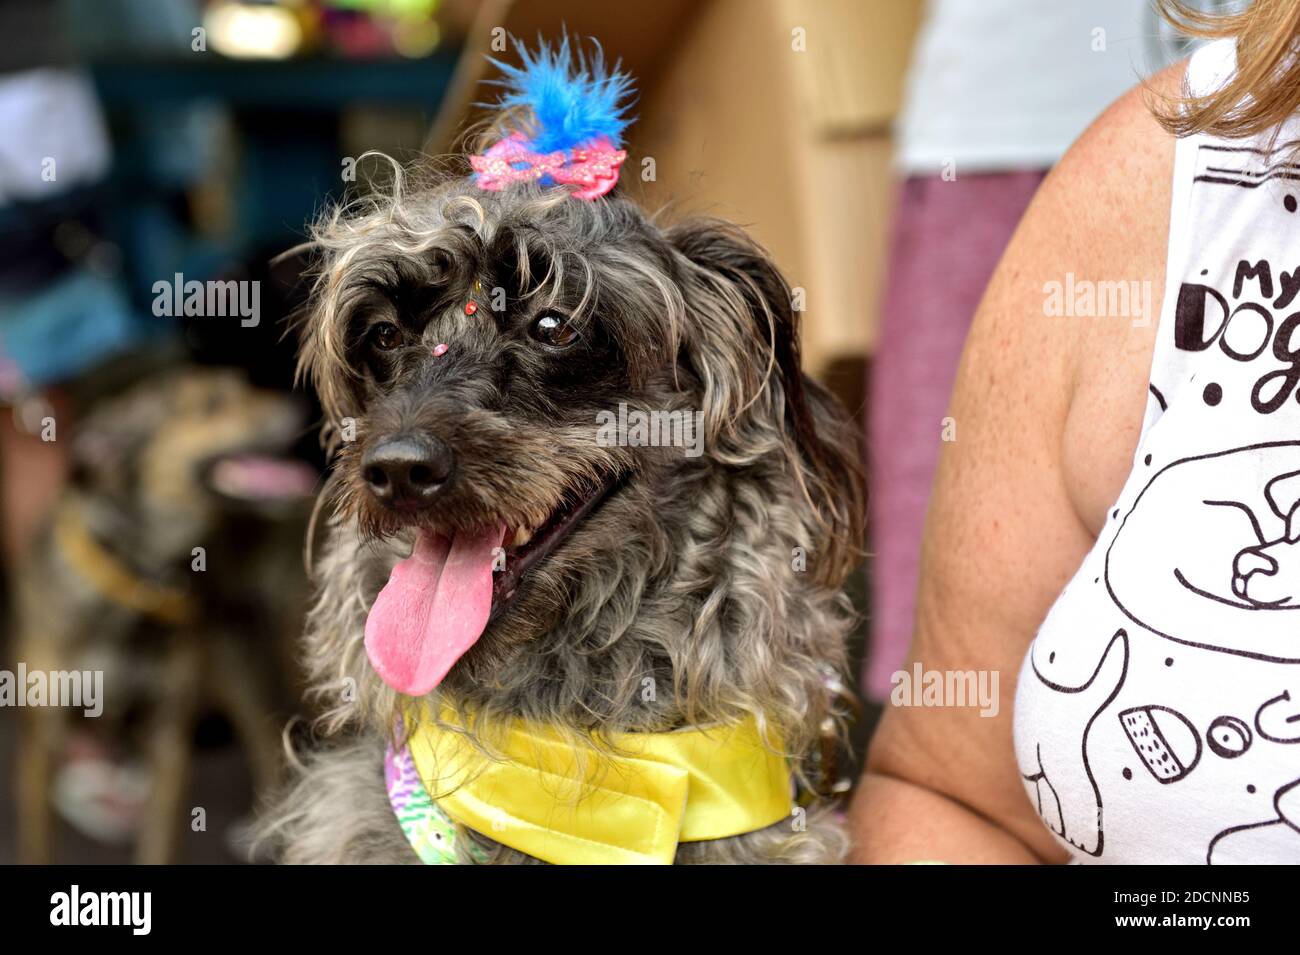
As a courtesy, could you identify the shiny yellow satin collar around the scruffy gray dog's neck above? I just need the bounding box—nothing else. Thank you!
[408,707,793,865]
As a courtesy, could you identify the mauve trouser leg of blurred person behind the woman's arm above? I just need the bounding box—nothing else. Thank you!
[865,170,1045,699]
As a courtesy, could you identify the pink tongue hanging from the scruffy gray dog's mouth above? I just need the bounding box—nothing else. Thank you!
[365,525,506,696]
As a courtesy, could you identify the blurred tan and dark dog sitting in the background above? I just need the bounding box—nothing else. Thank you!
[14,366,316,863]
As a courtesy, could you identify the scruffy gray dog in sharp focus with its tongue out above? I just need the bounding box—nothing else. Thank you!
[264,44,865,863]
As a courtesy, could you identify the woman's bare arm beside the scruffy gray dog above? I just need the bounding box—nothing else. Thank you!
[852,65,1183,863]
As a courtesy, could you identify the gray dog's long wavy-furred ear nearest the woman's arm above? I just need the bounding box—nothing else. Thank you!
[666,220,866,585]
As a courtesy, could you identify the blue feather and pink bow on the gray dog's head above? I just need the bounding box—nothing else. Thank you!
[469,35,633,199]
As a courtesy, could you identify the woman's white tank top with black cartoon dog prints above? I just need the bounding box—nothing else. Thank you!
[1015,42,1300,864]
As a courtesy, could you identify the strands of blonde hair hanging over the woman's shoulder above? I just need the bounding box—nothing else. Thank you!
[1153,0,1300,139]
